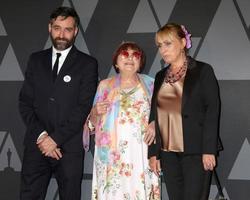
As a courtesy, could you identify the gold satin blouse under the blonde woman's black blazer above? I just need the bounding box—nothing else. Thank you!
[157,76,185,152]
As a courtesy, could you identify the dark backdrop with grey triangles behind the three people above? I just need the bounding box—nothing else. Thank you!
[0,0,250,200]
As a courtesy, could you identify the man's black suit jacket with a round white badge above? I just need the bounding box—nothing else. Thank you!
[19,46,98,152]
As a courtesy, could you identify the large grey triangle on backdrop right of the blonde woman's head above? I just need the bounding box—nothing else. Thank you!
[197,0,250,80]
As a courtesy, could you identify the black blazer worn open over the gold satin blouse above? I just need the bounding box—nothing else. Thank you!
[148,57,220,158]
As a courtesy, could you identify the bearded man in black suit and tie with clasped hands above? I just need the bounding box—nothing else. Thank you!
[19,7,98,200]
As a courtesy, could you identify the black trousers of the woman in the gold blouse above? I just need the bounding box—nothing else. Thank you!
[161,151,211,200]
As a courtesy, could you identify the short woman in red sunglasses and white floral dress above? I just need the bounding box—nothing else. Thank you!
[85,42,160,200]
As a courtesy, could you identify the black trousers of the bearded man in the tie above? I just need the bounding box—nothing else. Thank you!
[20,148,84,200]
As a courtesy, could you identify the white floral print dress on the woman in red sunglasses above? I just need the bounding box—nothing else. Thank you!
[92,75,160,200]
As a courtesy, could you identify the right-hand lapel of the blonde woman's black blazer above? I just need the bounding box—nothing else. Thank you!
[182,57,199,110]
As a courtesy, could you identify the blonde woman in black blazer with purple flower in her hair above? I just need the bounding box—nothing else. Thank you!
[149,23,220,200]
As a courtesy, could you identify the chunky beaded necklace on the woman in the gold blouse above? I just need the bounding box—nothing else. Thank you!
[165,60,187,84]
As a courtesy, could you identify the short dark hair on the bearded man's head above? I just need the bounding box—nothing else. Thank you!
[50,7,80,26]
